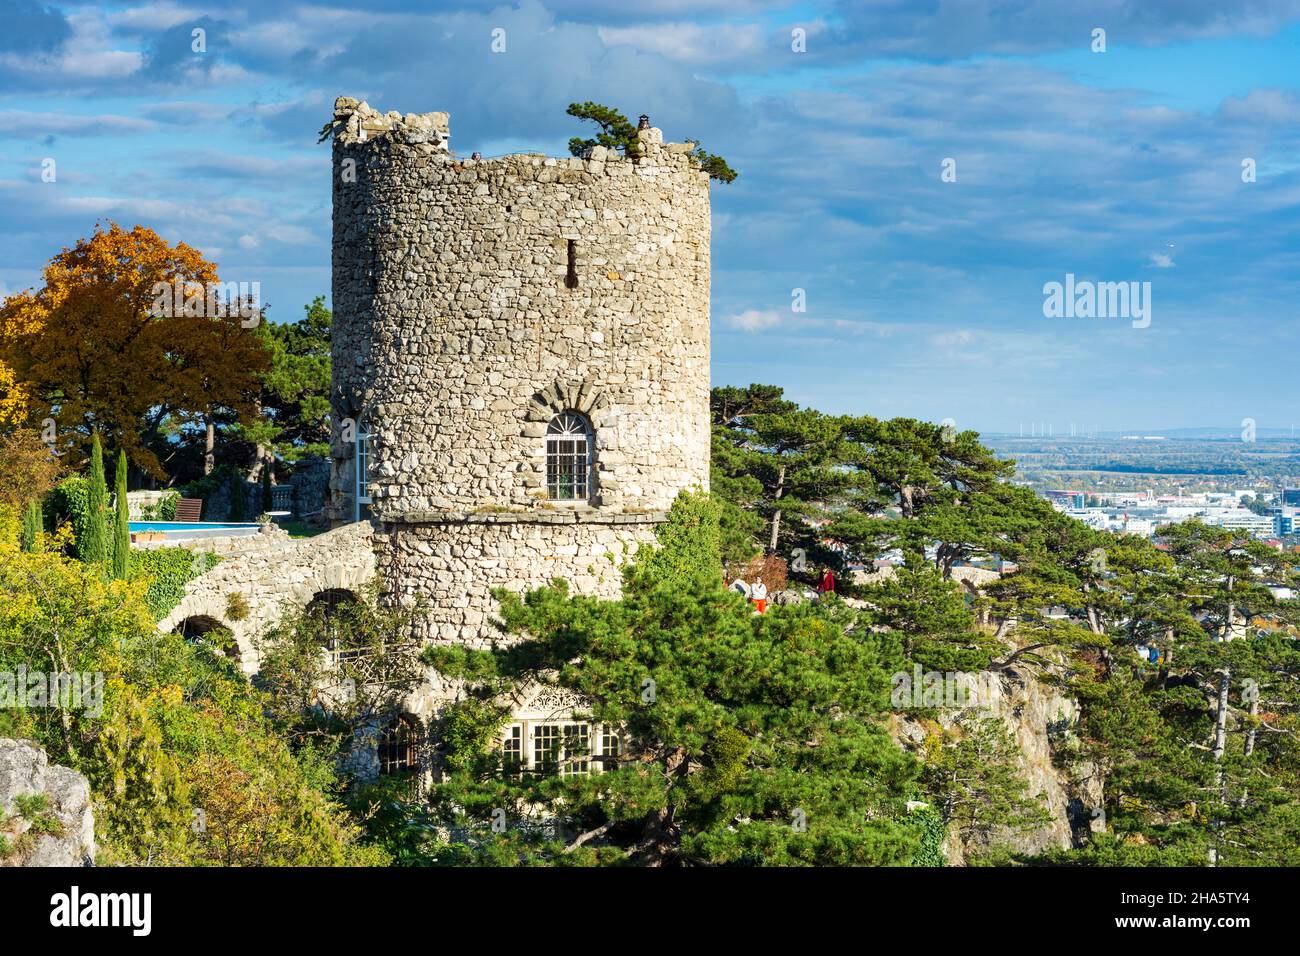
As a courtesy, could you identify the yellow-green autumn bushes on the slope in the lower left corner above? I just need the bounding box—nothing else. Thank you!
[0,515,386,865]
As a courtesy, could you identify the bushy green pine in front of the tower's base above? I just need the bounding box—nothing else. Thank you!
[426,496,919,865]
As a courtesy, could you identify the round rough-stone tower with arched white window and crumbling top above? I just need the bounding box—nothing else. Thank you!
[332,98,710,644]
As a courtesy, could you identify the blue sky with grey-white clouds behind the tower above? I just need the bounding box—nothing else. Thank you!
[0,0,1300,434]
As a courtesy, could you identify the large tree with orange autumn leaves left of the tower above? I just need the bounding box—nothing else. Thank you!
[0,222,268,479]
